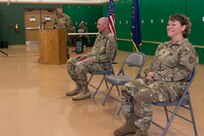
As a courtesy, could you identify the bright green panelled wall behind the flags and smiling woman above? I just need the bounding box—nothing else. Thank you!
[103,0,204,64]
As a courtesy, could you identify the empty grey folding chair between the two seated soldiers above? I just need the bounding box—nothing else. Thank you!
[103,52,145,105]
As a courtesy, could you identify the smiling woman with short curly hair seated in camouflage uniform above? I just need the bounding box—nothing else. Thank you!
[114,14,198,136]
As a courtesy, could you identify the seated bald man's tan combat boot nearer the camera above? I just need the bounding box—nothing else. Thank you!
[72,85,91,101]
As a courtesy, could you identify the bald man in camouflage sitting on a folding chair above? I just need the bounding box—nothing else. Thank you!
[66,17,117,101]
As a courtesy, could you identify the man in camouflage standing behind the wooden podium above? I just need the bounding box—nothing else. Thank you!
[54,6,73,58]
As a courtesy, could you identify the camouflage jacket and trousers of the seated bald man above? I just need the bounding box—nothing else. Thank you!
[67,33,116,99]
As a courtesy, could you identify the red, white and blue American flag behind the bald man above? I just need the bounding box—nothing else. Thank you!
[108,0,116,37]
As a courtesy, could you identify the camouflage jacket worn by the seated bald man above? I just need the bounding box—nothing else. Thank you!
[85,33,117,63]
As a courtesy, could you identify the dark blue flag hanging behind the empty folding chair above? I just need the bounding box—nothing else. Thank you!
[132,0,142,52]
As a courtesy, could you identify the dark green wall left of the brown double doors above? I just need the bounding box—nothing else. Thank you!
[0,3,56,45]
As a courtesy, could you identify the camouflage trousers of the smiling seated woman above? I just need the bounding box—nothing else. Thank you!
[121,78,185,130]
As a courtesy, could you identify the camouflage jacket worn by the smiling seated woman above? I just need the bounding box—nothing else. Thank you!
[145,39,198,82]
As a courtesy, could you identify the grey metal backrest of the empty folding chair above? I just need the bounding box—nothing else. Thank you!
[118,52,145,78]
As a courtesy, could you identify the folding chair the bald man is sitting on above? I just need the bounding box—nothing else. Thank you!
[88,47,118,99]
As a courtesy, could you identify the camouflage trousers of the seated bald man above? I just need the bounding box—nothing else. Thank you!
[67,58,106,86]
